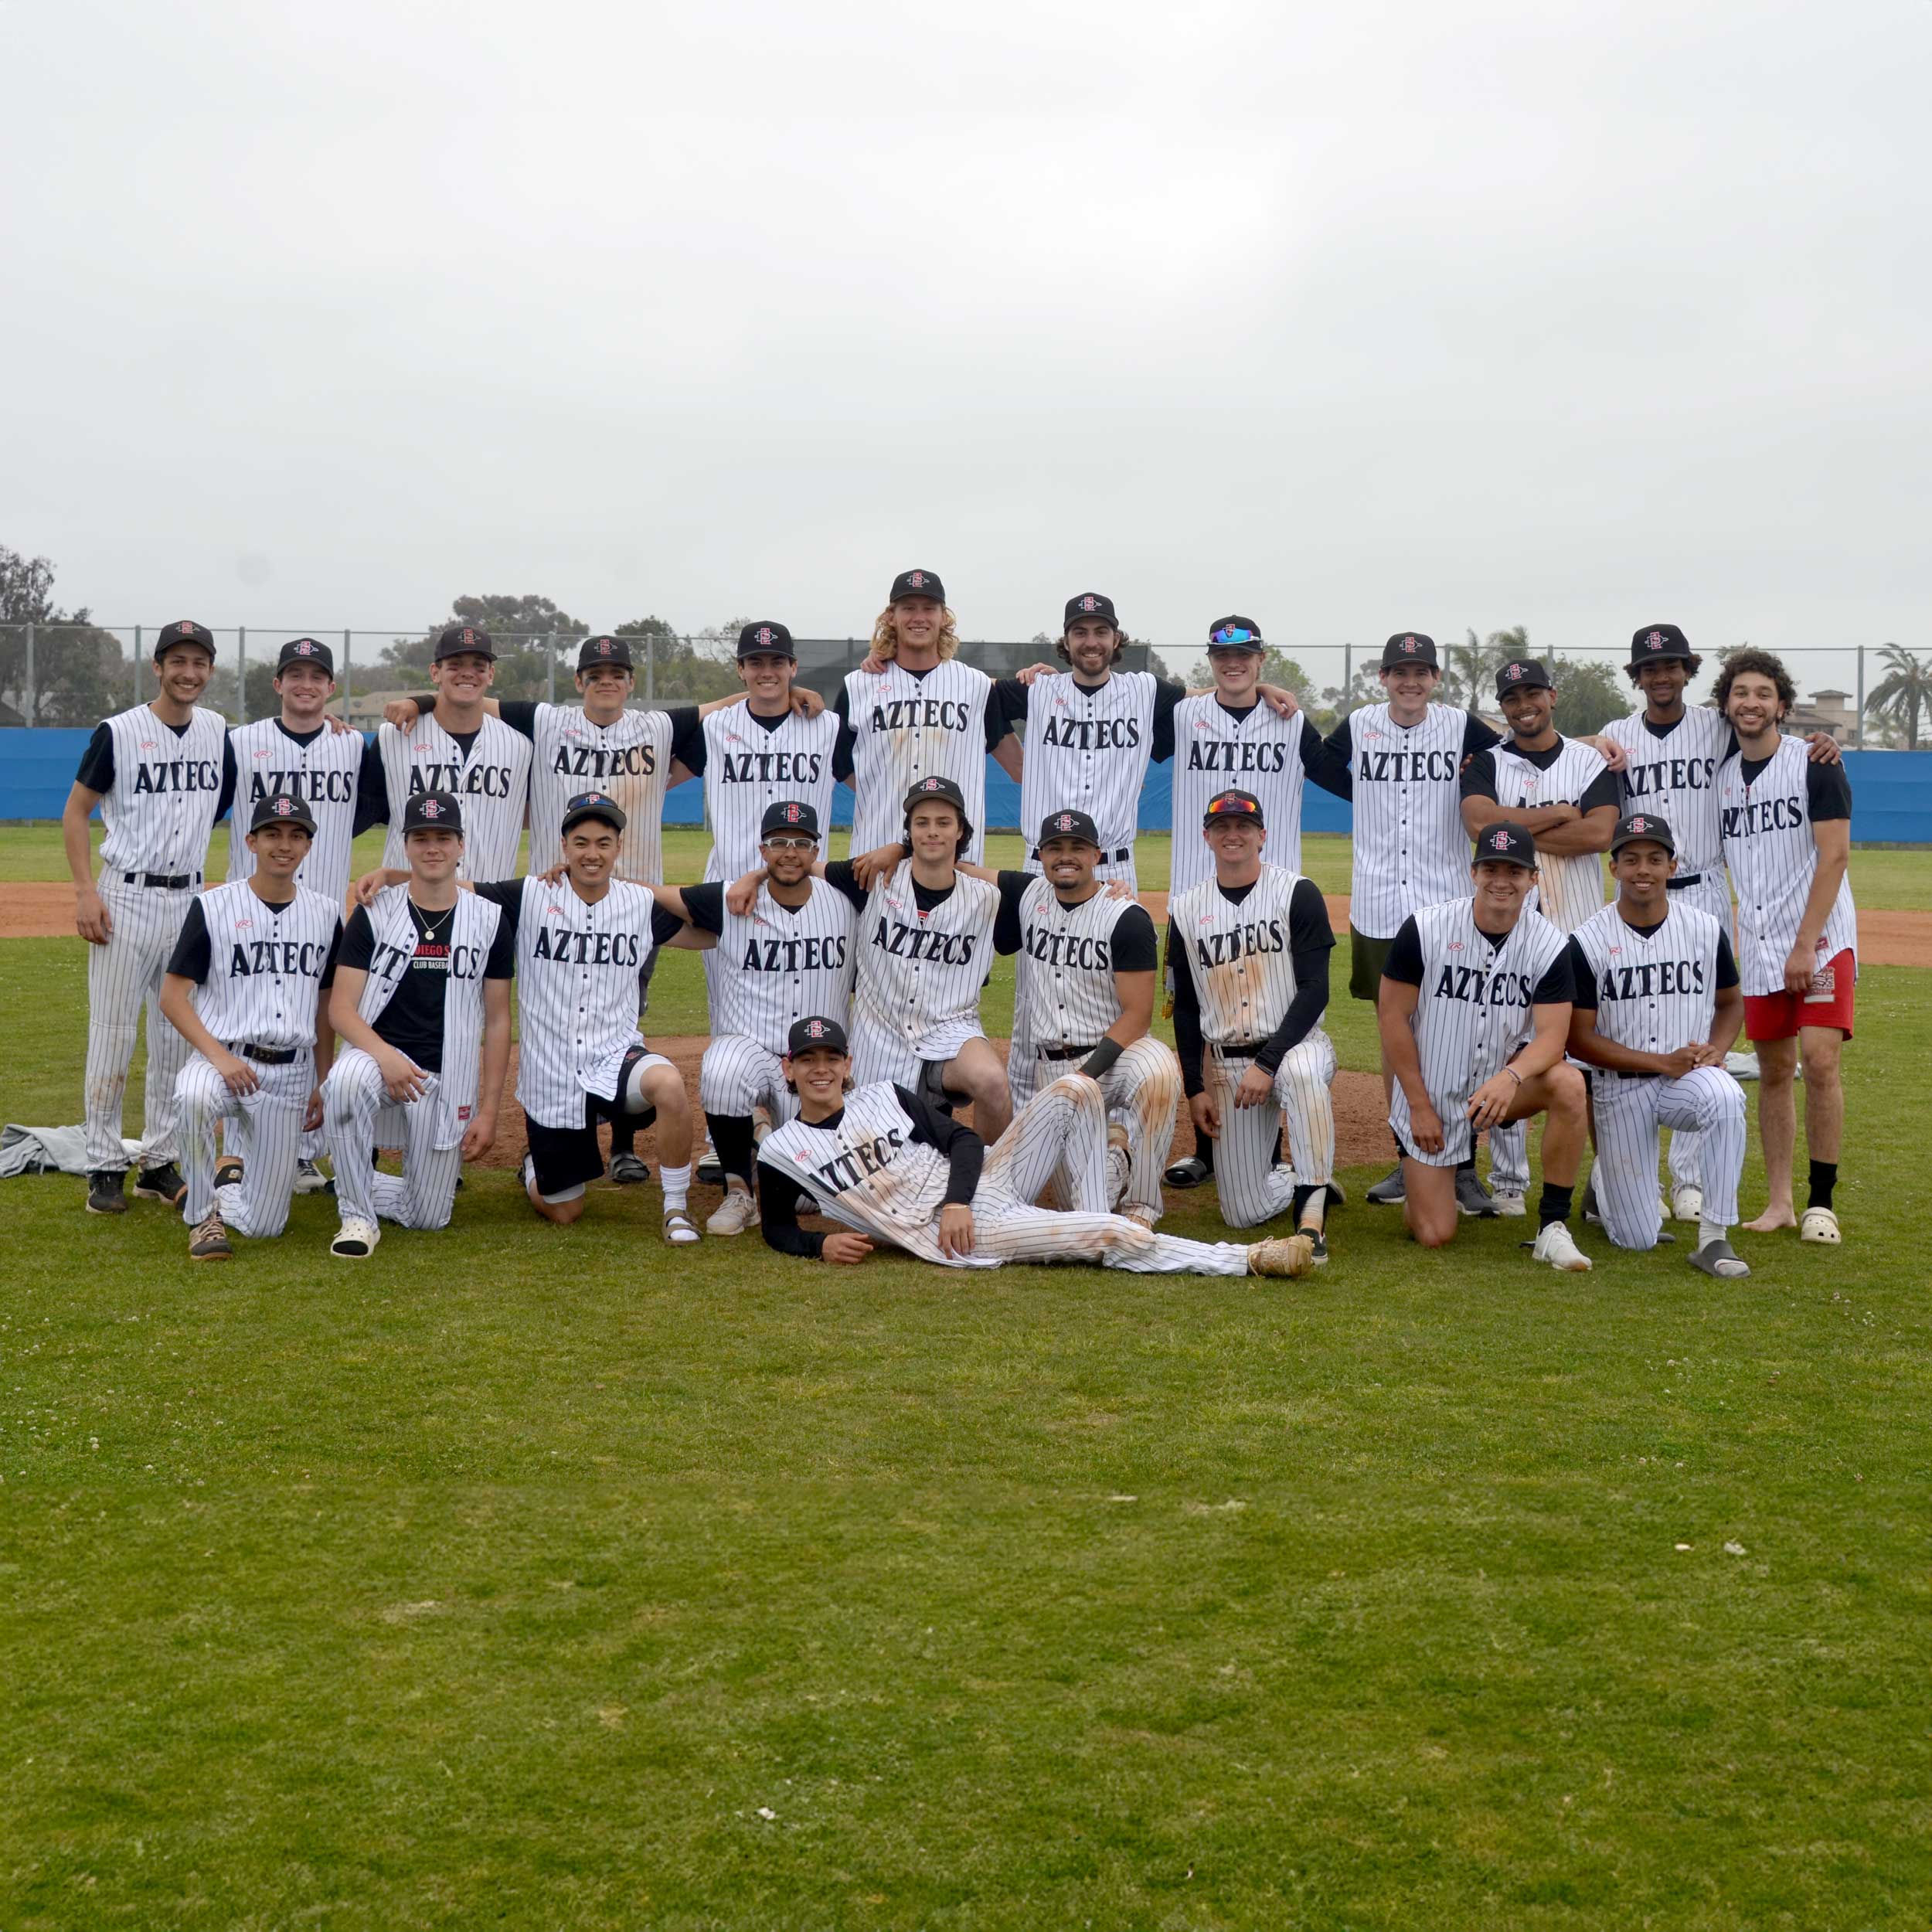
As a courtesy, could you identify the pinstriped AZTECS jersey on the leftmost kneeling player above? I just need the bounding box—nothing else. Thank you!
[184,881,342,1047]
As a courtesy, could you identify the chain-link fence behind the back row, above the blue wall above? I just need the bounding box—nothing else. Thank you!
[0,624,1932,750]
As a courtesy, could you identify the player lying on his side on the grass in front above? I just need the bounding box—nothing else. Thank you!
[757,1016,1310,1275]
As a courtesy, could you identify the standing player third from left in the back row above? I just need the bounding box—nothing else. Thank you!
[375,624,529,879]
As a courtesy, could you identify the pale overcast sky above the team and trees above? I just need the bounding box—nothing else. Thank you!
[0,0,1932,682]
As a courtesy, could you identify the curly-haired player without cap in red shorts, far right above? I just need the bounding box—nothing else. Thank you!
[1706,651,1859,1247]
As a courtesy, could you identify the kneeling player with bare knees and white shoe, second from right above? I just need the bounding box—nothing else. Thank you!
[1376,819,1592,1271]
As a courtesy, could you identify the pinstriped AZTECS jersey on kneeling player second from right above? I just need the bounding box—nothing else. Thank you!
[1389,893,1569,1165]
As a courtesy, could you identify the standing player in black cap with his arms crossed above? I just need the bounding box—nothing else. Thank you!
[1463,657,1617,1216]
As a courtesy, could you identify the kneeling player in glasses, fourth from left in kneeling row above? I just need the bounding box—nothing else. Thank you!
[651,798,858,1235]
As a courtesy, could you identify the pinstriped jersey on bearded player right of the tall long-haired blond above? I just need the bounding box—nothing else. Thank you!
[1020,671,1158,868]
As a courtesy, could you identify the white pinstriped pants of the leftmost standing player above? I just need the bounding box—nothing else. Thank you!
[85,873,205,1175]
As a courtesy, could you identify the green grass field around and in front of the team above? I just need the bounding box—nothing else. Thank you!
[0,831,1932,1932]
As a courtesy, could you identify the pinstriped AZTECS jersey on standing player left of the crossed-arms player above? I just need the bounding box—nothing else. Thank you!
[1345,706,1468,939]
